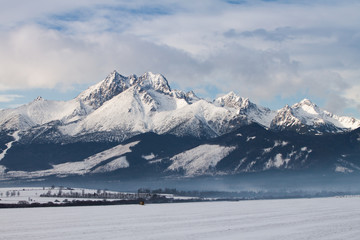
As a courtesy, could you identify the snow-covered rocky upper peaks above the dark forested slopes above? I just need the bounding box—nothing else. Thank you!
[0,71,360,142]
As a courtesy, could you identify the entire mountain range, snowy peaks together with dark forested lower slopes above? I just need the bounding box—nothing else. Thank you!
[0,71,360,181]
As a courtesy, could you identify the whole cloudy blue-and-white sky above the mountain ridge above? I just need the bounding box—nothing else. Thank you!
[0,0,360,118]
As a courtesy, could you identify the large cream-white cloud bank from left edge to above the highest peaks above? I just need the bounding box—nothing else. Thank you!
[0,25,205,91]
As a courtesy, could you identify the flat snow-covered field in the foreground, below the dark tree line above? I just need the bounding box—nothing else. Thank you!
[0,197,360,240]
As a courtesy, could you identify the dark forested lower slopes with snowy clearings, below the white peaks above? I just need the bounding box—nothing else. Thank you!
[0,123,360,180]
